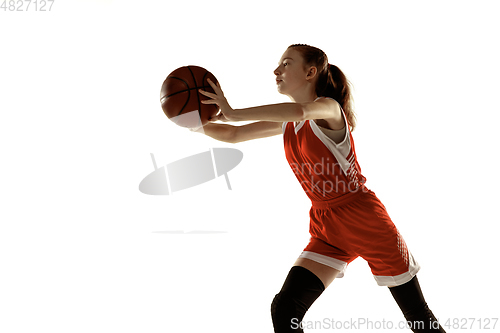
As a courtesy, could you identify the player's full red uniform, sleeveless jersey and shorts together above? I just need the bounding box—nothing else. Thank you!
[283,96,420,286]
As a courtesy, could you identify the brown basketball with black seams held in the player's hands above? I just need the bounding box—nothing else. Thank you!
[160,66,219,128]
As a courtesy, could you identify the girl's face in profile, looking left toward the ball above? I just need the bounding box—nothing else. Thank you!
[274,48,309,96]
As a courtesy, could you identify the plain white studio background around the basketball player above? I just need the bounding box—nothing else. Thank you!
[0,0,500,333]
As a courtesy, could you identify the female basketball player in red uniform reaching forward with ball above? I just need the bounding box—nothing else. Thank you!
[195,44,444,333]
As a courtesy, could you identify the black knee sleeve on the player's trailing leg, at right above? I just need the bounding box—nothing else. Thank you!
[389,276,445,333]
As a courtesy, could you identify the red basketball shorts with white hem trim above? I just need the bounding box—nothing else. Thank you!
[299,188,420,286]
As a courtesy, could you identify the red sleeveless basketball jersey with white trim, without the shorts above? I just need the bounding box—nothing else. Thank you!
[283,97,366,201]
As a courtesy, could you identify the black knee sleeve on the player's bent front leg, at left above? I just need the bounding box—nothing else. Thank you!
[271,266,325,333]
